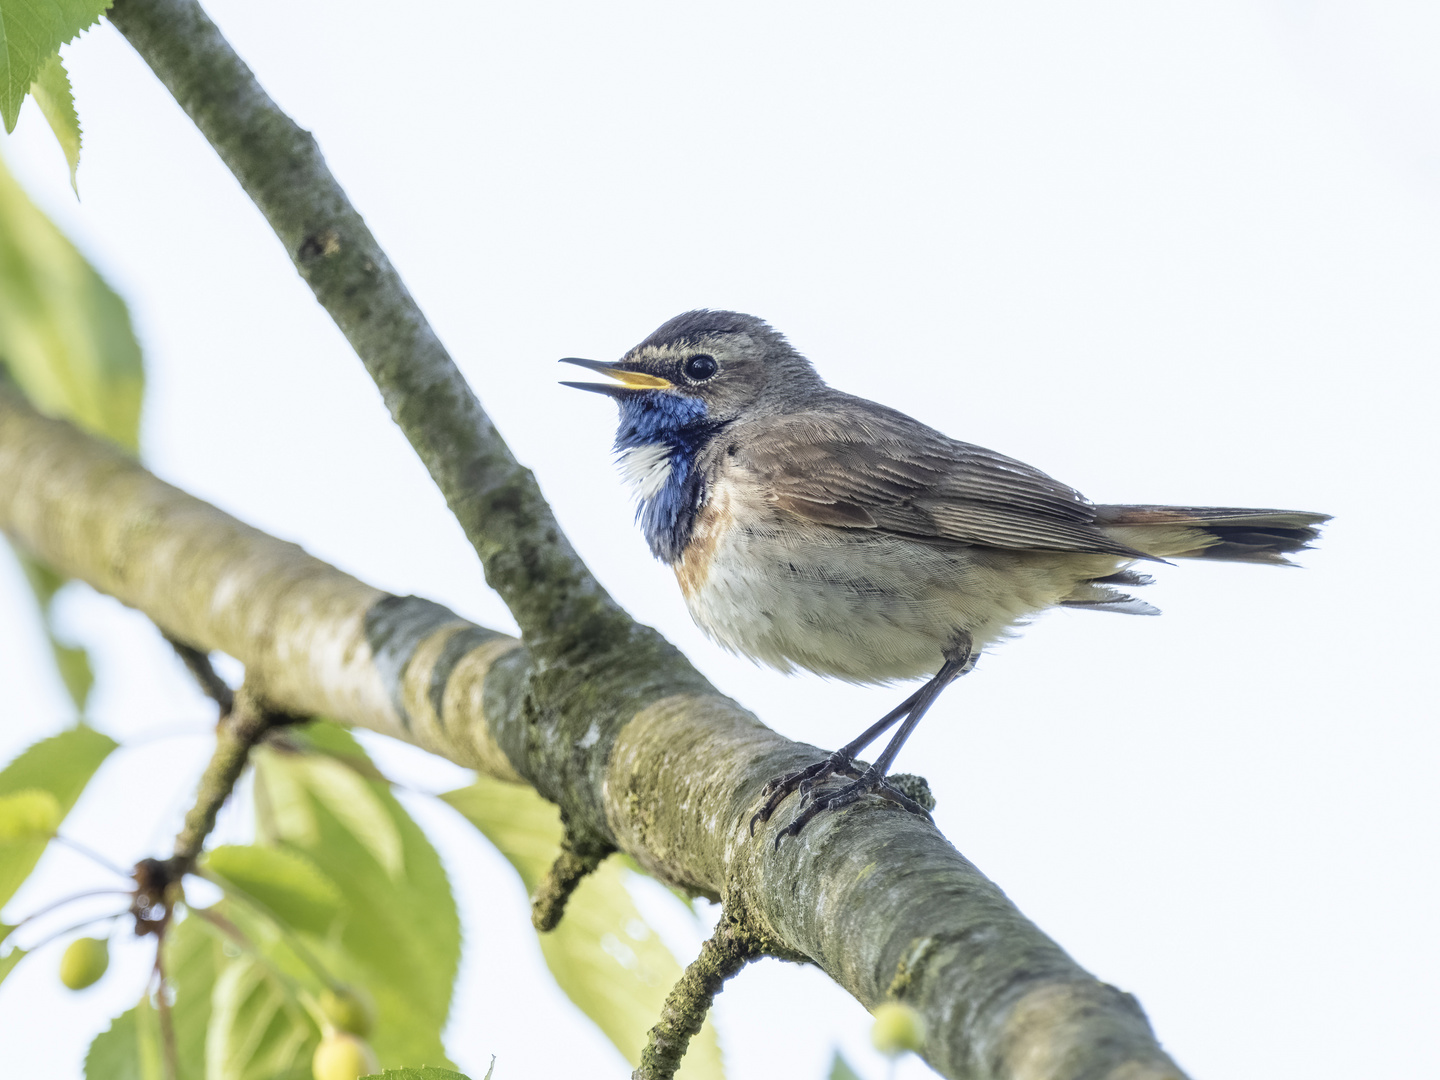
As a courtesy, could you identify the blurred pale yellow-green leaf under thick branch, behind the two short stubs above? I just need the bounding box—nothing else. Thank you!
[441,776,724,1080]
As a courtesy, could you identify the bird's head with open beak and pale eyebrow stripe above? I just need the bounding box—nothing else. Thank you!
[562,311,824,449]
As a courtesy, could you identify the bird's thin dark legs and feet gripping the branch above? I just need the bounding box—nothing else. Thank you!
[750,635,976,847]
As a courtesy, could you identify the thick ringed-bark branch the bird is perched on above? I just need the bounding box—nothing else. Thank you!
[0,387,1182,1080]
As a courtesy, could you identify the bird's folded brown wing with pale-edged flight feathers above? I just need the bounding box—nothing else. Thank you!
[734,395,1140,556]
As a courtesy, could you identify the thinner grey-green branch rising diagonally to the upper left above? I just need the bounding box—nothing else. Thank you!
[107,0,635,668]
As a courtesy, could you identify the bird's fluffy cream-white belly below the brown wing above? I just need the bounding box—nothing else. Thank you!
[675,507,1100,683]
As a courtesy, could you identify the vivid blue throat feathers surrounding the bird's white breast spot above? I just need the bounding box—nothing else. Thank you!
[615,390,724,564]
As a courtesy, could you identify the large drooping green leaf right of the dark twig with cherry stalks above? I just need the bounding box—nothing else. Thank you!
[250,721,459,1066]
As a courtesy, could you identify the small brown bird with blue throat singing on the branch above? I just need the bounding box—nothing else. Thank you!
[562,310,1329,847]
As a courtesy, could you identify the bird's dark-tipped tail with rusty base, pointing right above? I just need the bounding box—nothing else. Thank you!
[1094,505,1331,566]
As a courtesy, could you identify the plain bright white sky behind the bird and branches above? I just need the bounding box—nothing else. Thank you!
[0,0,1440,1080]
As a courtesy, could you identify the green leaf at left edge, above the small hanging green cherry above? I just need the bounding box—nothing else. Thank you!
[0,724,117,907]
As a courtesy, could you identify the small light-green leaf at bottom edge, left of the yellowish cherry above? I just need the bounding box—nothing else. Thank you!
[204,956,320,1080]
